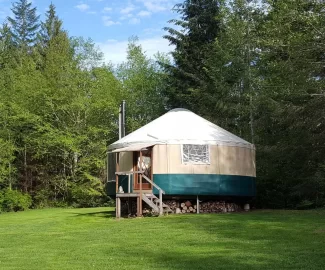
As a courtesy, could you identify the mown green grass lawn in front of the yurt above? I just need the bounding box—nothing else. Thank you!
[0,208,325,270]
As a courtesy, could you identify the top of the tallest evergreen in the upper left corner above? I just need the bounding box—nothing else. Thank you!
[7,0,39,49]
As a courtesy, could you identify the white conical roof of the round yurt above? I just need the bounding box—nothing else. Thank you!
[109,109,254,152]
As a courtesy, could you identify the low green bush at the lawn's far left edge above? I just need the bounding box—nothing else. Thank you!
[0,189,32,212]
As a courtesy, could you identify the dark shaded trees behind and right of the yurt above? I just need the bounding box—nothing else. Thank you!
[165,0,325,208]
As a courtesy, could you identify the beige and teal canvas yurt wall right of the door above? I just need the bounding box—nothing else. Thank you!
[153,145,256,197]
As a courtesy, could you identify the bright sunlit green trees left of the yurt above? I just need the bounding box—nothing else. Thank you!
[0,1,122,210]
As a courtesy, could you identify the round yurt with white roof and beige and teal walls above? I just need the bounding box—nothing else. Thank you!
[108,109,256,216]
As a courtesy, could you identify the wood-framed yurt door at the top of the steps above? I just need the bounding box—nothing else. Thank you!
[133,149,152,190]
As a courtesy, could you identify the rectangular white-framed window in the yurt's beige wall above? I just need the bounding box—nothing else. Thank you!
[182,144,210,164]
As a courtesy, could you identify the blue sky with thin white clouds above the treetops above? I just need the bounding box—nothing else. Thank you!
[0,0,181,63]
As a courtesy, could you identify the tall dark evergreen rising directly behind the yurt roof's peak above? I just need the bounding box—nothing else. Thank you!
[164,0,224,111]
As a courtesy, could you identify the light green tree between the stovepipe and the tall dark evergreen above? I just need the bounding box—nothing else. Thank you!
[116,38,168,132]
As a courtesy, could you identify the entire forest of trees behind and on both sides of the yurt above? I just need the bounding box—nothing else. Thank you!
[0,0,325,211]
